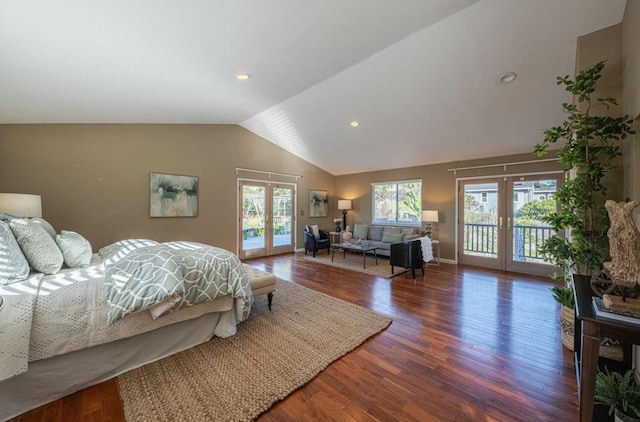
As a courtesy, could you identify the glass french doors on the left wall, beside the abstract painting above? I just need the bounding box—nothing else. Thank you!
[238,180,296,258]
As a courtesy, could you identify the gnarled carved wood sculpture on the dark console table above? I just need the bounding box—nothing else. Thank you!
[591,200,640,298]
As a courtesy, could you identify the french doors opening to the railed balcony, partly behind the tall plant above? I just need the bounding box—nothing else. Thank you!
[458,173,563,275]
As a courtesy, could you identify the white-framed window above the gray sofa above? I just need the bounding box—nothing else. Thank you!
[371,180,422,225]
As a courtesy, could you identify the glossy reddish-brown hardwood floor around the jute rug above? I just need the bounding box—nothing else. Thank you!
[14,254,578,422]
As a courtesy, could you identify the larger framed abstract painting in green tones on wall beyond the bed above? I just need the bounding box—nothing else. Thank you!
[149,173,198,217]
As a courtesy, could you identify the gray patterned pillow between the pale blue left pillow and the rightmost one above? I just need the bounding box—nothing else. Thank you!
[9,218,64,274]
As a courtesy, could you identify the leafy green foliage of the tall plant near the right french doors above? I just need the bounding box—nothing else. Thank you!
[534,61,634,281]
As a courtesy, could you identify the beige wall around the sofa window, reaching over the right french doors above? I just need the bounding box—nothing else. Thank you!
[336,153,561,260]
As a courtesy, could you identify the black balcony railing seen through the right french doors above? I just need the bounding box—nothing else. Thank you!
[464,223,552,262]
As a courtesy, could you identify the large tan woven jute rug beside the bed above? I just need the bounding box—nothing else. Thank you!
[118,280,391,422]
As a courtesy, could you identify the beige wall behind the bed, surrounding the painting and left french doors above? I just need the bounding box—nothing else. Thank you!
[0,125,340,251]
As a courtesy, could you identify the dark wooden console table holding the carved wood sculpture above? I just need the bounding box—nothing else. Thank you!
[573,275,640,422]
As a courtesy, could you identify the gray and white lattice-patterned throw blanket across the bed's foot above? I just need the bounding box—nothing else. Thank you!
[98,239,253,324]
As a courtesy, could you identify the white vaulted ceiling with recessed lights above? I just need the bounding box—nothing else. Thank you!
[0,0,626,175]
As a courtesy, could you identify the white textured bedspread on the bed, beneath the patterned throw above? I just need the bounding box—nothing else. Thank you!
[0,254,238,381]
